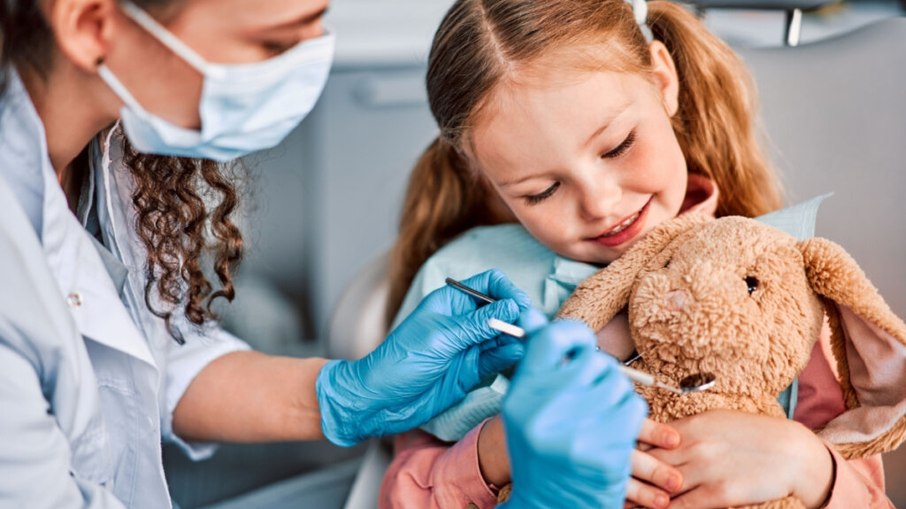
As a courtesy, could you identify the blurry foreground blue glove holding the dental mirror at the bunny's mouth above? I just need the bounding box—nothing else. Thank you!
[499,310,647,509]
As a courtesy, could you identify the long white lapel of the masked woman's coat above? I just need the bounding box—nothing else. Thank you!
[0,69,156,366]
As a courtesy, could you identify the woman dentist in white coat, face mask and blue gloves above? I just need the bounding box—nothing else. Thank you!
[0,0,645,509]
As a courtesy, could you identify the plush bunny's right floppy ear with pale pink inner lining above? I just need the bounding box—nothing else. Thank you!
[800,238,906,458]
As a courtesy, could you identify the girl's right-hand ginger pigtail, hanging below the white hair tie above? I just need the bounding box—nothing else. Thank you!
[648,1,781,217]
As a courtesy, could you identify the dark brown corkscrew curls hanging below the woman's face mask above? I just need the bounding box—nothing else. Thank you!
[120,134,243,344]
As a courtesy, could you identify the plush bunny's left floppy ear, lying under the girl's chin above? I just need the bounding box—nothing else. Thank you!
[557,213,712,330]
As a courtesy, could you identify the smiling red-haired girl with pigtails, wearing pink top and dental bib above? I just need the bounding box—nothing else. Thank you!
[381,0,891,508]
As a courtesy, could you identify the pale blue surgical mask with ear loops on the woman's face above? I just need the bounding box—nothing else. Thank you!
[98,2,334,161]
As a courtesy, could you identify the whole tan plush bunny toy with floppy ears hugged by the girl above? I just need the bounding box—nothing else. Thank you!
[559,214,906,508]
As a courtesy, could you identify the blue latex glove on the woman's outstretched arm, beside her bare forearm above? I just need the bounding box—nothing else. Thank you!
[317,270,529,446]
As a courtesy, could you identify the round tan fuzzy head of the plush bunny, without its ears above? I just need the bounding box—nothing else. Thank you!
[629,217,824,395]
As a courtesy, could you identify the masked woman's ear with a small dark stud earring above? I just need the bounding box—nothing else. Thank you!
[42,0,117,72]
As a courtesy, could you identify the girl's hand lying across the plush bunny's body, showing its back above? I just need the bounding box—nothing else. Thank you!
[649,410,834,509]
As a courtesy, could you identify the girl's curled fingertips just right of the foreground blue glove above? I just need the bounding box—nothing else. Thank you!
[624,419,683,509]
